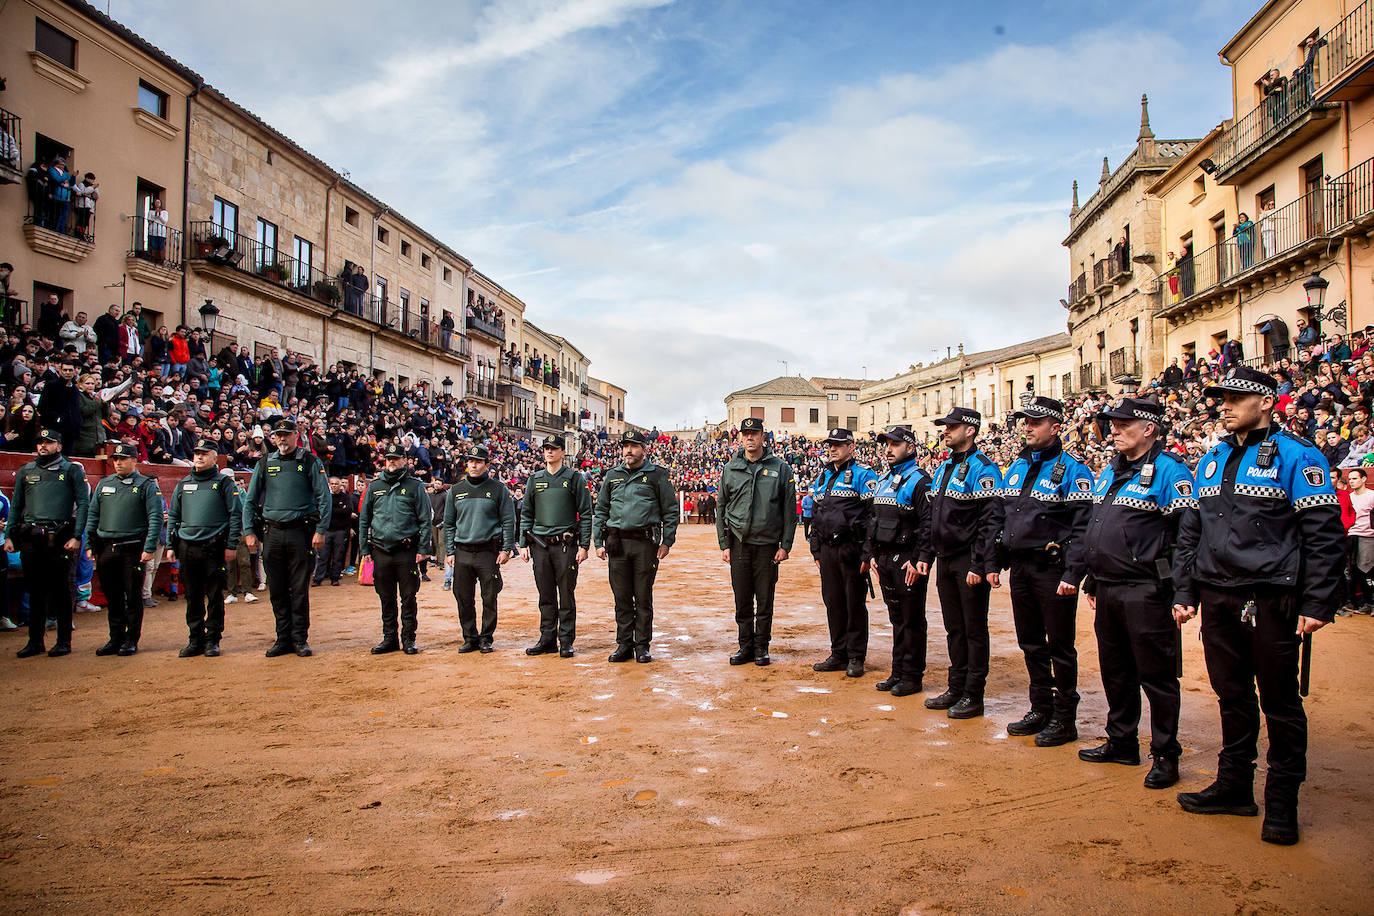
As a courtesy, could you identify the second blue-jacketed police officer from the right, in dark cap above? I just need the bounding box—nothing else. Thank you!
[1079,397,1197,788]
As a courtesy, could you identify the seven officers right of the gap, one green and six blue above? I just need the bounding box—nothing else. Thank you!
[717,367,1344,845]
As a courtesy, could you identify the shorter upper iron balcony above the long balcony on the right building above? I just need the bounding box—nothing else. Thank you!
[1212,67,1340,184]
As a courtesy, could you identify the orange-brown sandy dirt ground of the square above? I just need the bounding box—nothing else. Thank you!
[0,527,1374,913]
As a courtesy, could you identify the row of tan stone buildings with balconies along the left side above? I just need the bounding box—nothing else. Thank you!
[0,0,625,434]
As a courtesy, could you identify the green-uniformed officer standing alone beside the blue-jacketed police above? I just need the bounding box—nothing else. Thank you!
[716,416,797,666]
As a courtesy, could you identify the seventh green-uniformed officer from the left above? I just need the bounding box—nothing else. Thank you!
[519,435,592,658]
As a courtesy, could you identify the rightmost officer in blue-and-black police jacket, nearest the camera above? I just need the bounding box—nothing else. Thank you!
[1173,367,1344,846]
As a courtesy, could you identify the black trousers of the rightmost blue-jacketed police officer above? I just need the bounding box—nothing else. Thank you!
[1198,584,1307,799]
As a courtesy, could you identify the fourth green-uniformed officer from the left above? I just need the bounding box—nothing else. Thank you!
[243,417,333,658]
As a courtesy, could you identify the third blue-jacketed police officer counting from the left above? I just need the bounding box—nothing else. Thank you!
[921,407,1002,718]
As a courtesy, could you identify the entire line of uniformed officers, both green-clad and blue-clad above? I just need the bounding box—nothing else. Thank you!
[5,368,1344,843]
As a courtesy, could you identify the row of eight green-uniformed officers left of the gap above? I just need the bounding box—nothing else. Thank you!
[4,420,677,662]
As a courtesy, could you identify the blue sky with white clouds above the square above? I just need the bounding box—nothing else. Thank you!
[111,0,1259,426]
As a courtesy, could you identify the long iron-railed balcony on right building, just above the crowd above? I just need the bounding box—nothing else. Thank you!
[1160,159,1374,317]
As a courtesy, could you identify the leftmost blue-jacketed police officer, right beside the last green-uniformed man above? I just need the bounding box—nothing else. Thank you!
[809,430,878,677]
